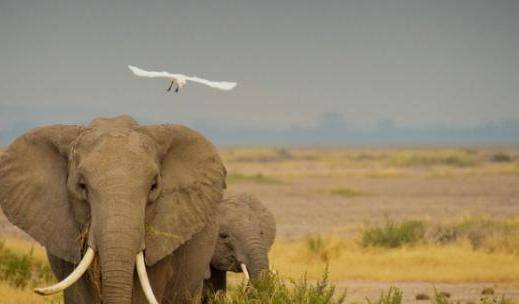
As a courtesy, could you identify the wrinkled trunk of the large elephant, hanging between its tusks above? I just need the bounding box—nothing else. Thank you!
[95,196,144,304]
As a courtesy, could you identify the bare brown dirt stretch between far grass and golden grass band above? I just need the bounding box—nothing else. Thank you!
[228,175,519,238]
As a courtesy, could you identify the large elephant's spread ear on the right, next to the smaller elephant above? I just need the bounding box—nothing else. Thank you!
[140,125,226,265]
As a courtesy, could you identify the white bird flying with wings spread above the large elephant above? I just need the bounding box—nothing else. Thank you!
[128,65,236,93]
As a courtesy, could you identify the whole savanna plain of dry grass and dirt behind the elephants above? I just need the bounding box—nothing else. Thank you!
[0,147,519,303]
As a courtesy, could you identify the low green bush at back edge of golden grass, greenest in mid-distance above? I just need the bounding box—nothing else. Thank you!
[362,219,425,248]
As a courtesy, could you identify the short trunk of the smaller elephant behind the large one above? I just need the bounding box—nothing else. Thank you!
[245,237,269,282]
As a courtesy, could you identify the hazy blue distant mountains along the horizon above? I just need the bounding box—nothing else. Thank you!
[0,113,519,146]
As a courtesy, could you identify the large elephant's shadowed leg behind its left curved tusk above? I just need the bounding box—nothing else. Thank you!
[47,252,100,304]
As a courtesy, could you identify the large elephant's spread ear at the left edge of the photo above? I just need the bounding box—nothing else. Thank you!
[0,125,81,263]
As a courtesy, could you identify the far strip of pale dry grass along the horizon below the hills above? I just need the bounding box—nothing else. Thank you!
[221,147,519,178]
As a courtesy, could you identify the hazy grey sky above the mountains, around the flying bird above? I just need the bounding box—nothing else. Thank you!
[0,0,519,132]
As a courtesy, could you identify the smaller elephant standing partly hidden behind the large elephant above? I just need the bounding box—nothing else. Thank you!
[205,194,276,292]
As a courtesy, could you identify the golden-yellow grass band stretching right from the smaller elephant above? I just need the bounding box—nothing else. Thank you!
[270,237,519,283]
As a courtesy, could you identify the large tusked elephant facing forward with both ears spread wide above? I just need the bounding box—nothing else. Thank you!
[0,116,225,303]
